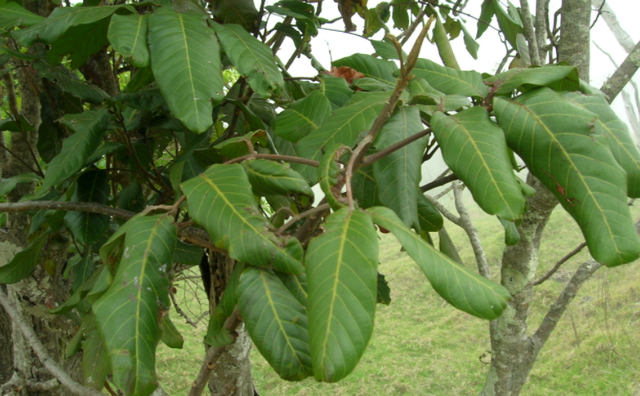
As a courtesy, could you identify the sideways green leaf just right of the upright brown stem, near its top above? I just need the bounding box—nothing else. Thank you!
[412,59,488,98]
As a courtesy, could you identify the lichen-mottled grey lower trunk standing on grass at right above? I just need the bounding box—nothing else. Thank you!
[480,175,558,395]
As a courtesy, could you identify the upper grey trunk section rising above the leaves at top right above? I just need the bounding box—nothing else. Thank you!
[558,0,591,82]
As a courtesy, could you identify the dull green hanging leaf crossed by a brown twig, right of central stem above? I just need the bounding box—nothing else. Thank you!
[373,106,428,230]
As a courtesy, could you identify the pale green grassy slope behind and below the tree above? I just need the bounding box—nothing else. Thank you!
[157,201,640,396]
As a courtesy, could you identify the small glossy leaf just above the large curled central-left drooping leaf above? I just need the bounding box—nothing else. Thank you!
[243,159,313,197]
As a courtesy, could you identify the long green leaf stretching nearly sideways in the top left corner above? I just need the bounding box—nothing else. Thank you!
[13,5,136,47]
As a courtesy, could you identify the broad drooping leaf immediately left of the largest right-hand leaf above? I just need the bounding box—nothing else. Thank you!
[431,107,525,221]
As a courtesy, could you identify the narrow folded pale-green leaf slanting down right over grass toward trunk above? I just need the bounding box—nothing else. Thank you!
[368,206,510,319]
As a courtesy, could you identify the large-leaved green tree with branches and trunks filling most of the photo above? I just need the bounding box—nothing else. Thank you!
[0,0,640,395]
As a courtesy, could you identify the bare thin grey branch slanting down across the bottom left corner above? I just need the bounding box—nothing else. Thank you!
[0,288,104,396]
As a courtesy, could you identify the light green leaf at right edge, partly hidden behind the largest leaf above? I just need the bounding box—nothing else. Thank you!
[564,93,640,198]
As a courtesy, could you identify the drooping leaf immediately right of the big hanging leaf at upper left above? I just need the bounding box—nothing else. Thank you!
[213,23,284,99]
